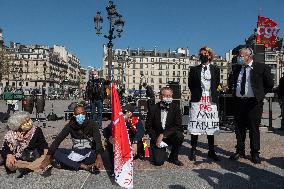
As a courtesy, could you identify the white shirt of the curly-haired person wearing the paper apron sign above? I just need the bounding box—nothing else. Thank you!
[201,64,211,96]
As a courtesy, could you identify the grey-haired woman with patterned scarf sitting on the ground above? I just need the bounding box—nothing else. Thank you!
[1,112,48,177]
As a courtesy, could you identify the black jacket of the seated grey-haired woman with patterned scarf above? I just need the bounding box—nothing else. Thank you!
[1,127,48,159]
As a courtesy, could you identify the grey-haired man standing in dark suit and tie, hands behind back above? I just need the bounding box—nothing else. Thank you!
[230,48,273,164]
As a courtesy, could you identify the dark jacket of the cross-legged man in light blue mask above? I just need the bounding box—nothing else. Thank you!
[48,117,103,155]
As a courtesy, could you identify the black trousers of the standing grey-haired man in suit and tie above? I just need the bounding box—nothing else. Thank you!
[234,97,263,155]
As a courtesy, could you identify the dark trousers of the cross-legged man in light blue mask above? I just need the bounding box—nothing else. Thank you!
[54,148,97,171]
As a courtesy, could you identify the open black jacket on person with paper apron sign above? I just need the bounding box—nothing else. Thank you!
[188,64,220,103]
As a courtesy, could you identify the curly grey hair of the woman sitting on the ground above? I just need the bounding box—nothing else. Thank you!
[7,111,30,130]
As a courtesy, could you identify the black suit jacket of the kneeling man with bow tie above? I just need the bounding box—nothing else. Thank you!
[145,102,183,140]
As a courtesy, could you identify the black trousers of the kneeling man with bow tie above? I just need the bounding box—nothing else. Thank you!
[151,131,184,166]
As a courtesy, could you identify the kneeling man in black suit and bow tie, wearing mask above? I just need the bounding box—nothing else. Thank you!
[146,87,184,166]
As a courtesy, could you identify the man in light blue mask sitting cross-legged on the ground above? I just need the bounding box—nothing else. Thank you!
[41,105,103,171]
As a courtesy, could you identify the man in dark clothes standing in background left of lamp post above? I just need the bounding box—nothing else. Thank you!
[85,70,105,128]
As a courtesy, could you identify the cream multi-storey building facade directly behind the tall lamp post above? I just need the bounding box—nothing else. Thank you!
[103,46,228,99]
